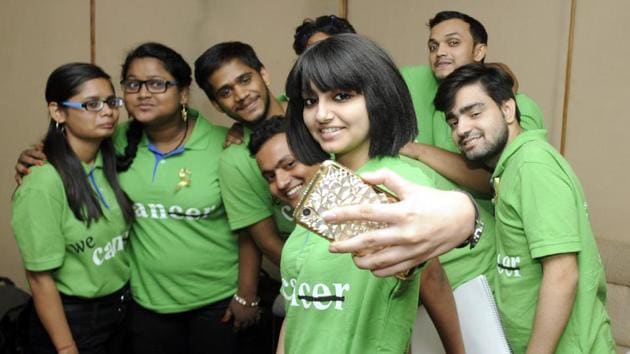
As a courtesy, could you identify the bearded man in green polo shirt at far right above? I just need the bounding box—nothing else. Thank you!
[435,64,615,353]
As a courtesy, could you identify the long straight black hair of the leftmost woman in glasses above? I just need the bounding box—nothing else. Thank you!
[44,63,134,226]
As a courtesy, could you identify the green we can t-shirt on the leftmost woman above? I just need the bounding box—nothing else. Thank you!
[12,153,129,298]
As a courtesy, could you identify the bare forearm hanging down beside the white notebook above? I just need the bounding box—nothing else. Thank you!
[420,258,466,354]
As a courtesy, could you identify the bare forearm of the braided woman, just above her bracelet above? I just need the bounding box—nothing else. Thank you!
[238,232,262,302]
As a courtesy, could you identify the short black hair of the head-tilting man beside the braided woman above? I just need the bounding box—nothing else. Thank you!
[195,42,264,102]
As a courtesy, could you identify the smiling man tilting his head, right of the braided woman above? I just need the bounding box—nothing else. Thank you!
[195,42,295,302]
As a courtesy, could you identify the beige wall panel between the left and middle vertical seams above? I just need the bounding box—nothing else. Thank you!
[96,0,338,125]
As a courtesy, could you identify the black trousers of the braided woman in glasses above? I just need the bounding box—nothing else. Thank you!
[129,297,258,354]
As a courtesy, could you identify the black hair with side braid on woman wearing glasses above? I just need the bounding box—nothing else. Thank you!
[118,42,192,171]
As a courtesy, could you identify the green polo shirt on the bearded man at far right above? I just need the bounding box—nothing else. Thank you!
[493,130,615,354]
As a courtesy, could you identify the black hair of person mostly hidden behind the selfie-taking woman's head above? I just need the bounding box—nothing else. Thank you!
[293,15,357,55]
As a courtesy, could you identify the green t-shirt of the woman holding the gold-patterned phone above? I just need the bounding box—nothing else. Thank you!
[280,158,433,354]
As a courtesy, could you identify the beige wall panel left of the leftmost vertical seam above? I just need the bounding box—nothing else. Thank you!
[0,0,90,290]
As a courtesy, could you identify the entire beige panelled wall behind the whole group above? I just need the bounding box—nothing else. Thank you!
[0,0,630,290]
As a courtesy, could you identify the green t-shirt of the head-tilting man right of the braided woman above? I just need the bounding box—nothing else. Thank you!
[219,128,295,238]
